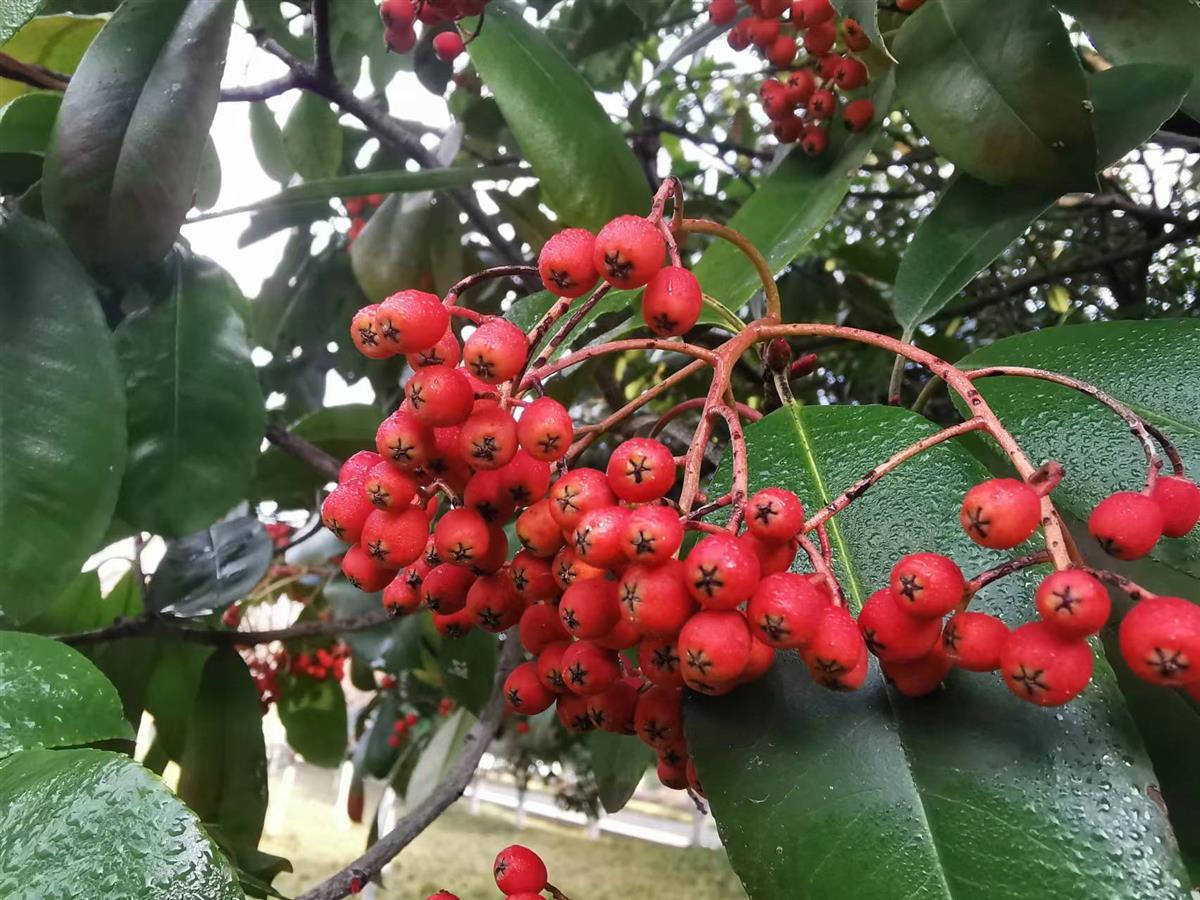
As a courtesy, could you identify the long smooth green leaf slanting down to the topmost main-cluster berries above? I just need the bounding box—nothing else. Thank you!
[467,4,649,229]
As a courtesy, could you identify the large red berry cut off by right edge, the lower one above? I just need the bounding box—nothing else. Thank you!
[1117,596,1200,688]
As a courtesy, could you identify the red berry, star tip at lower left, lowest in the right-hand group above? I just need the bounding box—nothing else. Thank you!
[1000,622,1092,707]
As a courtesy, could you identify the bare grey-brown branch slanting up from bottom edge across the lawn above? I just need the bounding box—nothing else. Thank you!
[296,628,522,900]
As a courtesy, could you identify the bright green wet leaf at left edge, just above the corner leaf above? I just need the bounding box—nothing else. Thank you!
[0,631,133,758]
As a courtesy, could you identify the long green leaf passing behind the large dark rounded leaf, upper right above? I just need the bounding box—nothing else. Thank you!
[895,64,1190,329]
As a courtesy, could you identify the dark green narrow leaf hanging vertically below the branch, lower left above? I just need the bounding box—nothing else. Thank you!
[178,647,266,850]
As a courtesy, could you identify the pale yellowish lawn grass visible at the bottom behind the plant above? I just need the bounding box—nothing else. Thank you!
[262,791,745,900]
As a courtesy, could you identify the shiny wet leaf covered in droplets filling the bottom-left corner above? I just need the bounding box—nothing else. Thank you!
[0,750,242,900]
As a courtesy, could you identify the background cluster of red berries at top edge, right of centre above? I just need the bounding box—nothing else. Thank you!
[708,0,875,156]
